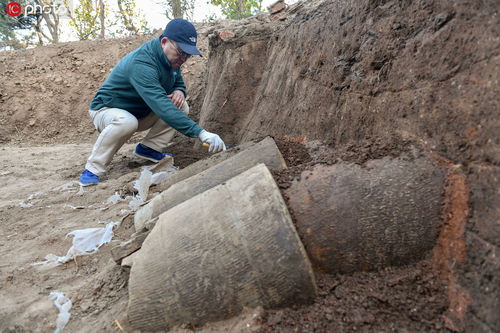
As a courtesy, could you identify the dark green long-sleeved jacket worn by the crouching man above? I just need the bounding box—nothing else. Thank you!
[90,38,202,138]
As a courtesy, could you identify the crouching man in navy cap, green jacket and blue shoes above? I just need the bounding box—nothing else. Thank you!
[80,19,226,186]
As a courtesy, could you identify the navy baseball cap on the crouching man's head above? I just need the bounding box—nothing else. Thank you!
[162,18,201,55]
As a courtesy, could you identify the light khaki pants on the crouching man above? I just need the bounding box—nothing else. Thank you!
[85,102,189,176]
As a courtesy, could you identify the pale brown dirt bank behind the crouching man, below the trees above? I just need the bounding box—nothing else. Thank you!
[0,26,208,144]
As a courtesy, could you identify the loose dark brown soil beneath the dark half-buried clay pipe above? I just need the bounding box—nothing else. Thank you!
[260,261,448,333]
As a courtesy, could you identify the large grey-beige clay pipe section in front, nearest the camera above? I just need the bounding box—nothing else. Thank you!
[128,164,316,331]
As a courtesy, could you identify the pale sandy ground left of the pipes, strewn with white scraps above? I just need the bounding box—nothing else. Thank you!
[0,144,150,332]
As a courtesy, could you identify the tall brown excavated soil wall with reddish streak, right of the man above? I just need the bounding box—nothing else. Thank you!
[200,0,500,332]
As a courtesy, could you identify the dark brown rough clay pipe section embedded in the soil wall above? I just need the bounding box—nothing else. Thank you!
[286,158,444,273]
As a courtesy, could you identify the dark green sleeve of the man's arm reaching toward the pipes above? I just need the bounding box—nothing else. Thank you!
[130,61,202,138]
